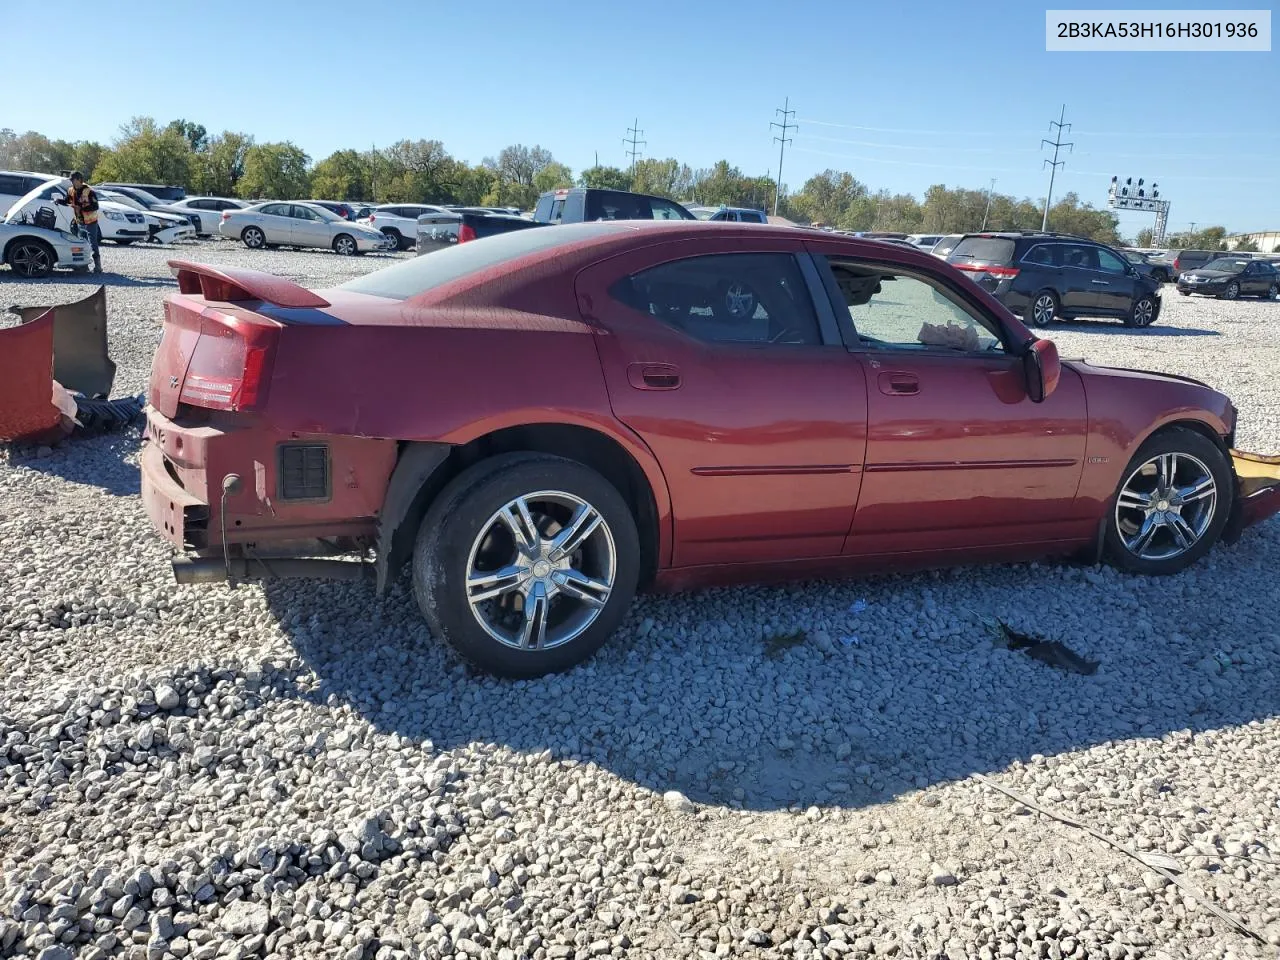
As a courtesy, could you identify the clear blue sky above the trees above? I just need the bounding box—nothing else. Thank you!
[0,0,1280,236]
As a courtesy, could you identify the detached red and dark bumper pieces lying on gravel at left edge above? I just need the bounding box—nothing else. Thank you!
[0,287,143,443]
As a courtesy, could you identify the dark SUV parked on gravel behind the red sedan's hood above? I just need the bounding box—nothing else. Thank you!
[947,233,1160,326]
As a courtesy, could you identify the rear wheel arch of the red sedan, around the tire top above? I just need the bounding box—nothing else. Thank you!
[376,422,671,594]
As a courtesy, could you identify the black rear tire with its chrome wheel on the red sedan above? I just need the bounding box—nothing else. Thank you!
[413,453,640,677]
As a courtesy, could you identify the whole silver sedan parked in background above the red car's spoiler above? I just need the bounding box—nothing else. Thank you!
[218,200,394,256]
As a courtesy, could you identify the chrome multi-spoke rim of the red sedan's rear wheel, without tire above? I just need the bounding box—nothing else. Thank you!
[466,490,618,650]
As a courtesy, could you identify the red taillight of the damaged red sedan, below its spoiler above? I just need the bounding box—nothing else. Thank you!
[178,315,276,412]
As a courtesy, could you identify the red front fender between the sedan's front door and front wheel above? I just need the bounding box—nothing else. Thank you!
[1064,361,1235,509]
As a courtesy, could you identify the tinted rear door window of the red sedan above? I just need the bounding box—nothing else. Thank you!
[609,253,822,346]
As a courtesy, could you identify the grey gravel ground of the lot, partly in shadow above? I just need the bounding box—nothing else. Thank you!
[0,242,1280,960]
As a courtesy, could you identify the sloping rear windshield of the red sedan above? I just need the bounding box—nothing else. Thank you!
[338,224,627,300]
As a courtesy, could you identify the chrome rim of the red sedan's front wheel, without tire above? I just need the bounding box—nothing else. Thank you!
[1116,453,1217,561]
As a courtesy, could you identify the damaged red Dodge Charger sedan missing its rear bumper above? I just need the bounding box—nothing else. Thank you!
[142,221,1280,676]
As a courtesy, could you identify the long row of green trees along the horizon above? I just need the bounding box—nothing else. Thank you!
[0,116,1208,246]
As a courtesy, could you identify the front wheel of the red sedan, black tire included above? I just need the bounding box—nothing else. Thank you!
[1106,428,1235,576]
